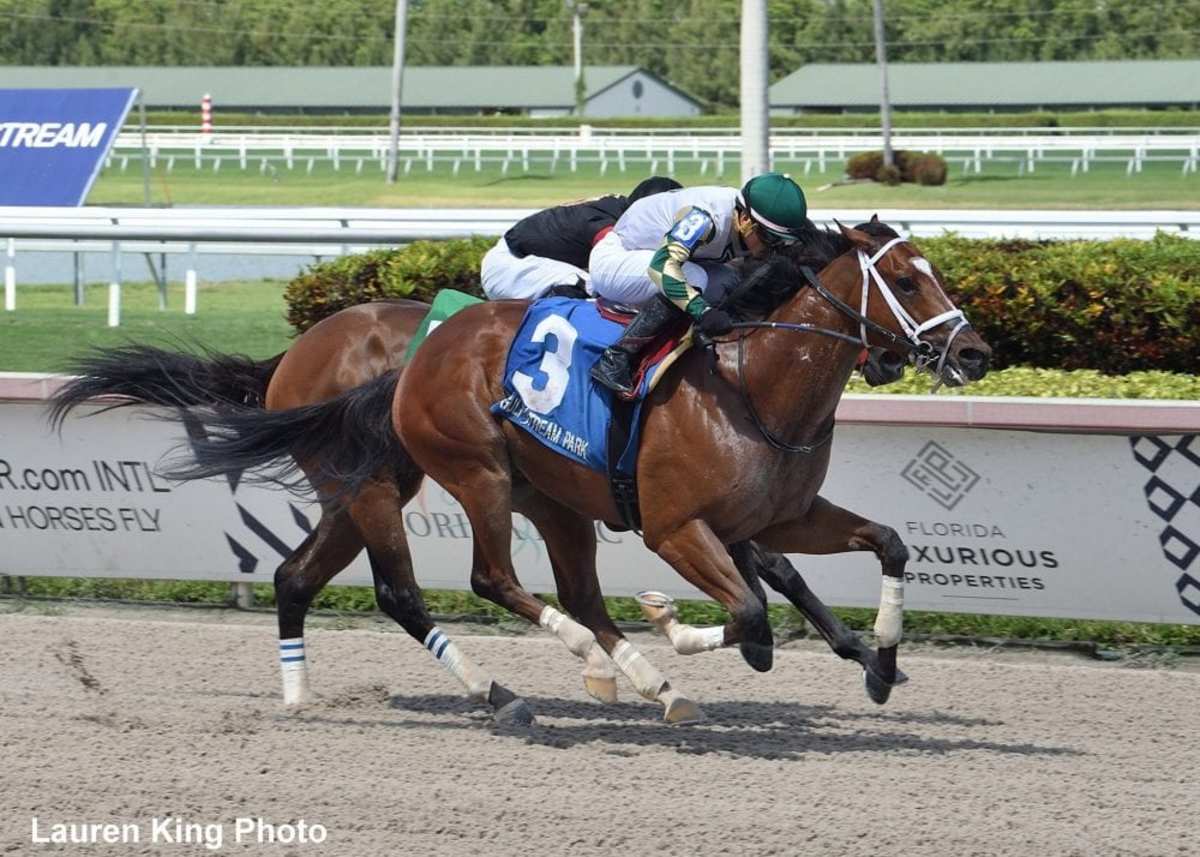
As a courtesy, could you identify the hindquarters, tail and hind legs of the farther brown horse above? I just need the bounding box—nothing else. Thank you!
[52,300,549,723]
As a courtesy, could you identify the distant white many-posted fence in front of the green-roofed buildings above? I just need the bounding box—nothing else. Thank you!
[109,126,1200,176]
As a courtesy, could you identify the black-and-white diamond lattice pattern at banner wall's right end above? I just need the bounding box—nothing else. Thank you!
[1129,435,1200,613]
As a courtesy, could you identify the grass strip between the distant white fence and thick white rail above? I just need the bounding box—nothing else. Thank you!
[88,152,1200,208]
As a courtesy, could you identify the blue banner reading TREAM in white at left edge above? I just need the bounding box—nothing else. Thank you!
[0,89,137,205]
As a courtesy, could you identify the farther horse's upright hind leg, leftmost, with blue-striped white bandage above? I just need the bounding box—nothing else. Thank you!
[275,510,362,705]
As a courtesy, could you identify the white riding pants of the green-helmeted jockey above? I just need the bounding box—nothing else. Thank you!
[588,232,737,307]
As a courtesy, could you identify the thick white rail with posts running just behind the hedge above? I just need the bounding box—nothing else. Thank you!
[0,206,1200,326]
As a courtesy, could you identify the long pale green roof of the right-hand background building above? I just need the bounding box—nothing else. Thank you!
[769,60,1200,114]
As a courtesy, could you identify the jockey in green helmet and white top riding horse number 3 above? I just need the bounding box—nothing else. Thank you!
[590,173,811,395]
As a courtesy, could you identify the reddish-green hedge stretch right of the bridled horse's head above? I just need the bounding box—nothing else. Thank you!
[919,233,1200,374]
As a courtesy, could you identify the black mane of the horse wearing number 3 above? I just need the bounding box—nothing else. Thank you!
[721,221,898,318]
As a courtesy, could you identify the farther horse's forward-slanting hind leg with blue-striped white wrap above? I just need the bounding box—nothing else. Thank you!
[350,473,533,725]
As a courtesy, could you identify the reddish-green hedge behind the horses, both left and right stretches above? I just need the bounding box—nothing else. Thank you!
[284,234,1200,374]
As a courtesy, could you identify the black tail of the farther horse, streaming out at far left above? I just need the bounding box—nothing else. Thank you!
[49,344,283,429]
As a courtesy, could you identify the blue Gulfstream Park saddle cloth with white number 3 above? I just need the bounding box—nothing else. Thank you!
[492,298,654,475]
